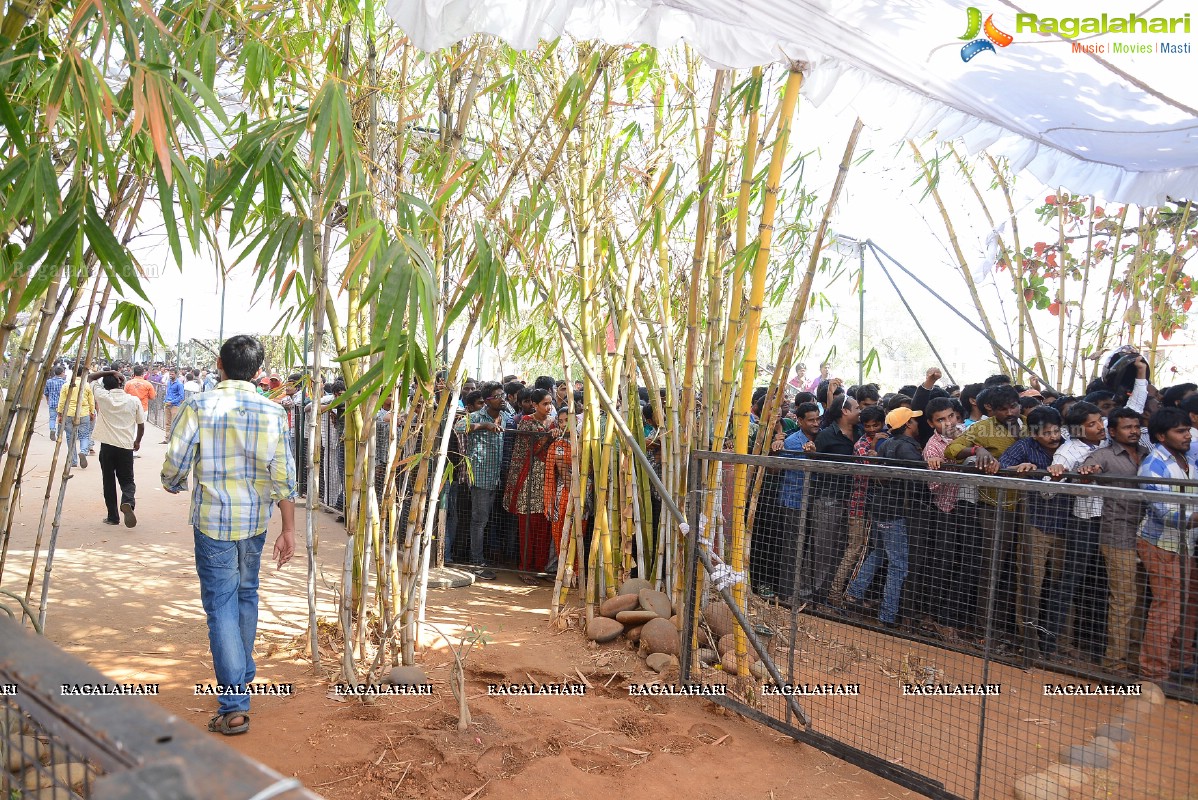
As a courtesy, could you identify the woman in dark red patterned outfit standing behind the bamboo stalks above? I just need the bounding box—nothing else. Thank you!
[503,389,557,572]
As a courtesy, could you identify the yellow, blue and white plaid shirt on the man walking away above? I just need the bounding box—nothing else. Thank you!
[162,381,296,541]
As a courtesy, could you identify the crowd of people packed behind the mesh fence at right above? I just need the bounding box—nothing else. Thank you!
[752,349,1198,681]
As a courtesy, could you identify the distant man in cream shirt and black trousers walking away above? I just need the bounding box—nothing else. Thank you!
[87,370,146,528]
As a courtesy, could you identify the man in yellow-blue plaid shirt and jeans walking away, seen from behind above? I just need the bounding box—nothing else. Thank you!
[162,337,296,735]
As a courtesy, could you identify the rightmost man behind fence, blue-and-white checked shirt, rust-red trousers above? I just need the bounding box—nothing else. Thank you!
[1136,408,1198,681]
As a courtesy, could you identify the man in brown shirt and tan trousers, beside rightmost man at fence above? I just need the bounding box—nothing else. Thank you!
[1083,406,1148,674]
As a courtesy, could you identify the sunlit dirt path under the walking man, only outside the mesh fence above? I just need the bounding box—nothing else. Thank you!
[4,410,915,800]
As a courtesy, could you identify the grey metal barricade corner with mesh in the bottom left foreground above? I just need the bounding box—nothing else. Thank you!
[0,616,319,800]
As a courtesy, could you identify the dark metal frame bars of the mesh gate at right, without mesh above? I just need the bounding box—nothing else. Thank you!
[679,450,1193,800]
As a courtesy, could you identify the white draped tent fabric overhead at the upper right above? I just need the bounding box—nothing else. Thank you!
[387,0,1198,205]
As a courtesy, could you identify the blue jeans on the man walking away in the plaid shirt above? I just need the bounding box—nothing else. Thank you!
[195,529,266,714]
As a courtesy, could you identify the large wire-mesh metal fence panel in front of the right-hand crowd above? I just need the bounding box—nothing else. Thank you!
[682,453,1198,799]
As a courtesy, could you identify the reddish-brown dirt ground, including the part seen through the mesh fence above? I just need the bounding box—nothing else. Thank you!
[4,411,1198,800]
